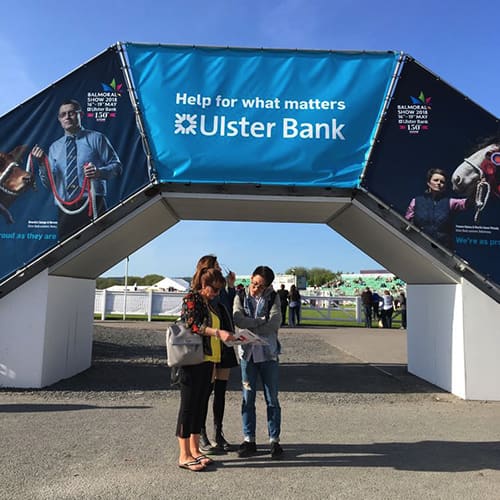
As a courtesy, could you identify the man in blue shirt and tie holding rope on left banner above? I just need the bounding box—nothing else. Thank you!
[31,99,123,240]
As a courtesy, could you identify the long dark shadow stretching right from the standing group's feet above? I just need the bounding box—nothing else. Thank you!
[218,441,500,472]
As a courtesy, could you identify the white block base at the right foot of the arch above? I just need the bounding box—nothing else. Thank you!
[407,280,500,401]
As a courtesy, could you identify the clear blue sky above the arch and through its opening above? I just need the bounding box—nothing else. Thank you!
[0,0,500,276]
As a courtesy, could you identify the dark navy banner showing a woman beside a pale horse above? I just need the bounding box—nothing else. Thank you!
[362,62,500,283]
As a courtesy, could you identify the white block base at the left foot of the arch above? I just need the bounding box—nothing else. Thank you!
[0,270,95,388]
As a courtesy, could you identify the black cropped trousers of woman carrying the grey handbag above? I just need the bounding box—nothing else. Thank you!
[175,361,214,438]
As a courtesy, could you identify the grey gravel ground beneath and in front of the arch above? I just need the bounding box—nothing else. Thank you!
[0,322,500,500]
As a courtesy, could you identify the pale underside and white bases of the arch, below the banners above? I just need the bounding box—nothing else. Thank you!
[0,188,500,399]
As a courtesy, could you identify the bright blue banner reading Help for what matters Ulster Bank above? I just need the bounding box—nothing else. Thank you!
[126,44,399,188]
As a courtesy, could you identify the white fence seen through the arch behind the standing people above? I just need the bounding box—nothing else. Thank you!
[94,290,363,323]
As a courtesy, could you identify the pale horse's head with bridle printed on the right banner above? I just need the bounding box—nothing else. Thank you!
[451,142,500,224]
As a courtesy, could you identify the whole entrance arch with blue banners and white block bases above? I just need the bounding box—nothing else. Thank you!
[0,43,500,399]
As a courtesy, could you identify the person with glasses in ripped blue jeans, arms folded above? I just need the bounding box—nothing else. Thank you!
[233,266,283,458]
